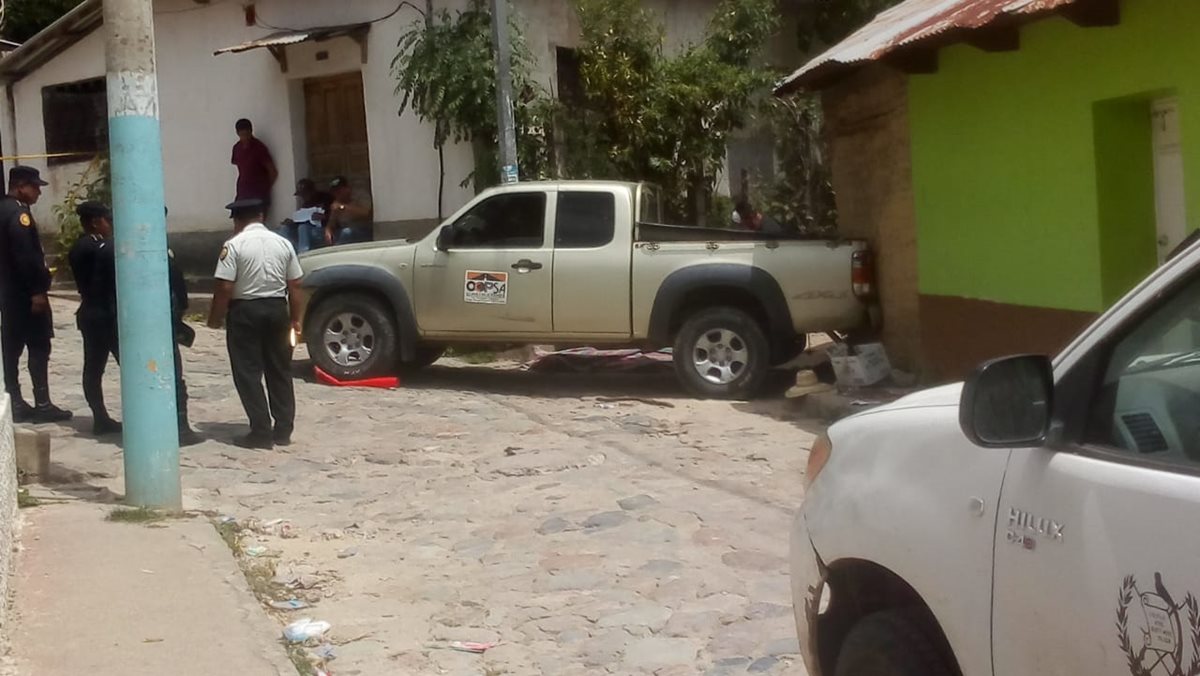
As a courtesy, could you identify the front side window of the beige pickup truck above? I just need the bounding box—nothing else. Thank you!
[454,192,546,249]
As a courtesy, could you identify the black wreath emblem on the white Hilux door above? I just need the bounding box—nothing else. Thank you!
[1117,573,1200,676]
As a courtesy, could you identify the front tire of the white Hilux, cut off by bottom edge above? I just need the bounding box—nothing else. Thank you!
[834,610,955,676]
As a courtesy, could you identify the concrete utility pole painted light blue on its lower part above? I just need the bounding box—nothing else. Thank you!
[104,0,182,509]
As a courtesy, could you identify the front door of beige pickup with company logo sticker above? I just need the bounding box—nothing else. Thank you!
[414,191,554,335]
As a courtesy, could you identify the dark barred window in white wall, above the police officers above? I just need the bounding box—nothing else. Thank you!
[42,78,108,164]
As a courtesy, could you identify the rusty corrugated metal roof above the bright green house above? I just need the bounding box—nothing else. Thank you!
[775,0,1078,94]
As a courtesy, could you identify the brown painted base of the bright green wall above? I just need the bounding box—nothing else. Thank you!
[920,294,1096,381]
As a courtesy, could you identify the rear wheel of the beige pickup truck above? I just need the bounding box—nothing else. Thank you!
[674,307,770,399]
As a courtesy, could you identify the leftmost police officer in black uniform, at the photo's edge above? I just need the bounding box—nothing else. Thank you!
[0,166,72,423]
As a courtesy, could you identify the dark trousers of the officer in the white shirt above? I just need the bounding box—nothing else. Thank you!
[226,298,296,436]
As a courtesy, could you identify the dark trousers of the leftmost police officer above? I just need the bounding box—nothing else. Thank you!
[0,297,54,403]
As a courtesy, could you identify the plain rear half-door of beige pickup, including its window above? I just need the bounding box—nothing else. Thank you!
[554,187,634,337]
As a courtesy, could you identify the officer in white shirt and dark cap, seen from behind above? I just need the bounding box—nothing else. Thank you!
[209,199,304,449]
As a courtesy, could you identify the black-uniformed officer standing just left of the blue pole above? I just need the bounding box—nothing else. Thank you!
[68,202,121,436]
